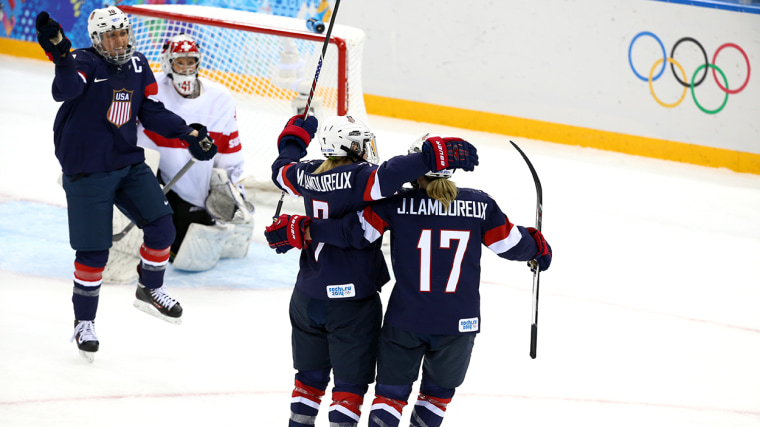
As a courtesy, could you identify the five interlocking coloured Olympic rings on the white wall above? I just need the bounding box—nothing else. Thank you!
[628,31,750,114]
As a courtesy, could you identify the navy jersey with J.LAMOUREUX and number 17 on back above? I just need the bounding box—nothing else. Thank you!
[311,188,538,335]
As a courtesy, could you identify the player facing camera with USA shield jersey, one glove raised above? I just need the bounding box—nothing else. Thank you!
[36,6,216,362]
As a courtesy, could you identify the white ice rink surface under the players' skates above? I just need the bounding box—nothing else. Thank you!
[0,55,760,427]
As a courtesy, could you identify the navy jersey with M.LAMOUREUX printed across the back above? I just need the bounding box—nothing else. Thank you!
[272,143,428,300]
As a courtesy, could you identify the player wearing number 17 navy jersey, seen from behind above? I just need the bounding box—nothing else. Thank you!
[273,136,552,427]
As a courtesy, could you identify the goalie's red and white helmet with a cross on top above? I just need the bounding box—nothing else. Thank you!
[161,34,202,96]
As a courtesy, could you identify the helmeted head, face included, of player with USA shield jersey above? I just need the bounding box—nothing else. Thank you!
[87,6,136,65]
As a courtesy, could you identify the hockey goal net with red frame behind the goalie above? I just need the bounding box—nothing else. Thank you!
[119,5,367,196]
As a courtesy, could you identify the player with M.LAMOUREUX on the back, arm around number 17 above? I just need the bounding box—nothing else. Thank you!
[265,116,478,427]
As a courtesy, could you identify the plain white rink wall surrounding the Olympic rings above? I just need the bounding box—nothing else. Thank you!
[337,0,760,154]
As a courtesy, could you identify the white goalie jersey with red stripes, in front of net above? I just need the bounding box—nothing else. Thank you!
[137,73,244,208]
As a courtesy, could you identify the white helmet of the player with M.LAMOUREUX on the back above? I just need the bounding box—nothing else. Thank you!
[319,116,380,164]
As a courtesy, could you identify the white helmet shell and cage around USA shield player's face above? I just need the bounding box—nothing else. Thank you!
[87,6,137,65]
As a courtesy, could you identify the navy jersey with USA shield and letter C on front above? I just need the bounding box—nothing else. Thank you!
[53,47,192,175]
